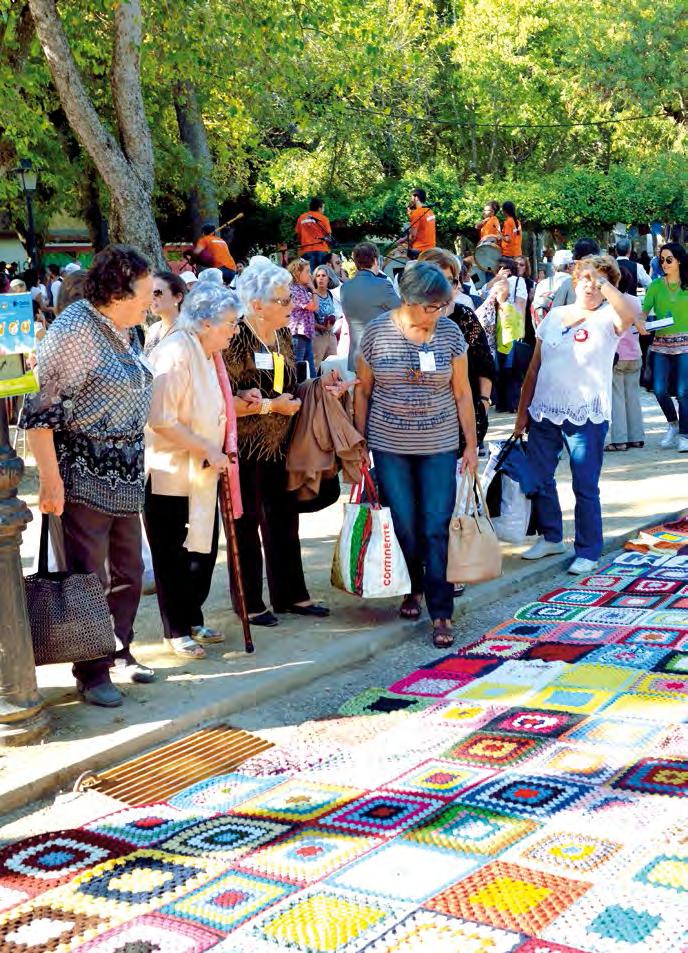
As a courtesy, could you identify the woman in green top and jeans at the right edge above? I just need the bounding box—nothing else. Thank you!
[638,242,688,453]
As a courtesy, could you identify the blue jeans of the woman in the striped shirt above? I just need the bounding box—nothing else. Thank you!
[373,450,457,619]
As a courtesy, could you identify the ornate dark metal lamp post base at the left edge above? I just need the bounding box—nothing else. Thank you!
[0,398,50,746]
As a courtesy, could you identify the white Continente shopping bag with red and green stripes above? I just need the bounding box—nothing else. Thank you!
[330,468,411,599]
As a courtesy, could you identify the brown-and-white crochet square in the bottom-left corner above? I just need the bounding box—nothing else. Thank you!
[0,903,105,953]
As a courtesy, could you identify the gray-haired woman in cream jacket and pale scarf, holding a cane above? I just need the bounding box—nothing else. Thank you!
[144,281,241,659]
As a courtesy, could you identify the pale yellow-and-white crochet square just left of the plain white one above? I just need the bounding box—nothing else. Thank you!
[236,827,380,886]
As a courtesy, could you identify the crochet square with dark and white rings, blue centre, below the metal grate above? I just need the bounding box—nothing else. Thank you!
[160,815,290,860]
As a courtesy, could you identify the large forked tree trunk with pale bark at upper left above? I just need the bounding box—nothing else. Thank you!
[29,0,164,267]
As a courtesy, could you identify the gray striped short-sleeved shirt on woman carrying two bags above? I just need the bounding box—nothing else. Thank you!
[361,312,467,454]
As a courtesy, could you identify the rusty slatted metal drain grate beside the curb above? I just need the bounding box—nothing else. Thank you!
[80,725,273,807]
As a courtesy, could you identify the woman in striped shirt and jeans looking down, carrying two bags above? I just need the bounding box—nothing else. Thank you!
[354,261,478,648]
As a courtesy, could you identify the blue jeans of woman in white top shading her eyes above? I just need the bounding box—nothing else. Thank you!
[528,417,609,560]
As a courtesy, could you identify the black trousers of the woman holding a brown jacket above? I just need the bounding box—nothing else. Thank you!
[232,460,310,613]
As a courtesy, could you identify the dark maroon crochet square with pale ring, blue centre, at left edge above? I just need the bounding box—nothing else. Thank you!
[0,830,131,896]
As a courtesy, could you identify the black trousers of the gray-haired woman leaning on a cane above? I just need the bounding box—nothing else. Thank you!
[143,480,219,639]
